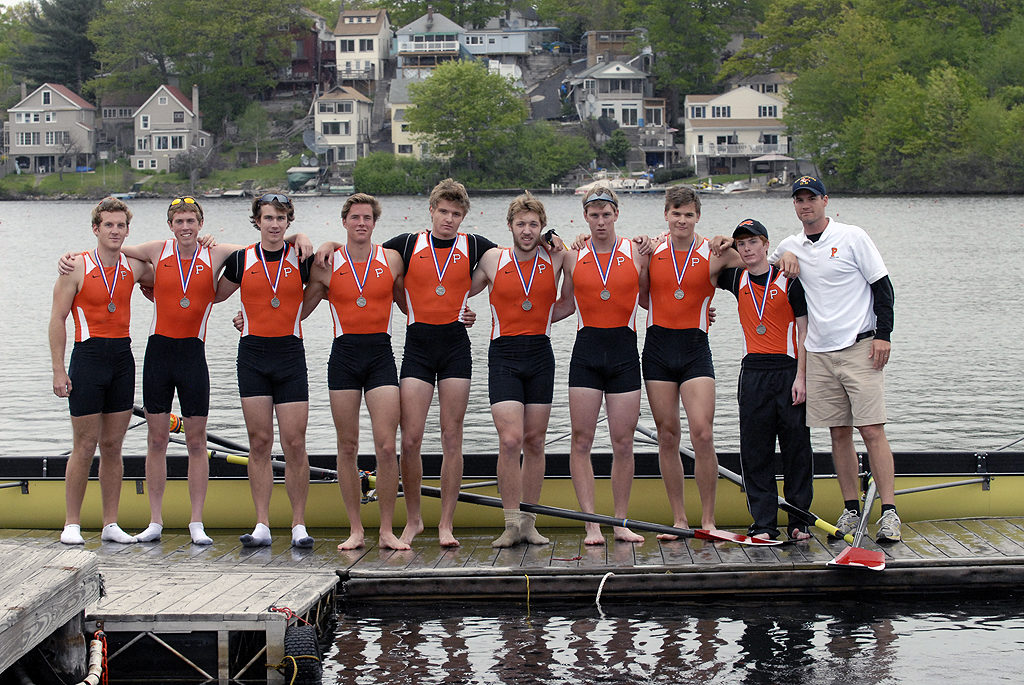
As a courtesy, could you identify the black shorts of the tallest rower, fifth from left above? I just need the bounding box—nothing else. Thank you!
[400,322,473,385]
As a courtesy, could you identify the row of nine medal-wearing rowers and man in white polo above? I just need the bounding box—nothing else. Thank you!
[49,176,900,550]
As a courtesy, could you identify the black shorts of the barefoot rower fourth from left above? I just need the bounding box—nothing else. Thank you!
[327,333,398,390]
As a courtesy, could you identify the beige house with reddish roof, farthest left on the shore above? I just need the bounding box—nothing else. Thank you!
[5,83,96,174]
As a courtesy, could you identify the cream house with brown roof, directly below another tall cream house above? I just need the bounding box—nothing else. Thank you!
[313,86,373,164]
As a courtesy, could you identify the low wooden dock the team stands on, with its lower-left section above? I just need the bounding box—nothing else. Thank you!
[0,518,1024,682]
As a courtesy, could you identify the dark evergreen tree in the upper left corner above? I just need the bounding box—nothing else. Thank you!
[7,0,103,92]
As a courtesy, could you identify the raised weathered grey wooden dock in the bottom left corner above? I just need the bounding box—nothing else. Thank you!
[0,541,100,674]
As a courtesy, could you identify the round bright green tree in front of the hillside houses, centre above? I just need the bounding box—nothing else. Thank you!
[406,61,527,171]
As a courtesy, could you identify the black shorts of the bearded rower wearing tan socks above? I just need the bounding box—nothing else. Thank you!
[487,335,555,404]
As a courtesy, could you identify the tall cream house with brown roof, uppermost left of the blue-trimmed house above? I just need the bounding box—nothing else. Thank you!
[334,9,394,85]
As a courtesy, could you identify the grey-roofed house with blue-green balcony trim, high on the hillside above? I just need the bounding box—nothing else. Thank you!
[395,8,473,79]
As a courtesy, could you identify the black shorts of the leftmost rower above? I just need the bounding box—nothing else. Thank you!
[68,338,135,417]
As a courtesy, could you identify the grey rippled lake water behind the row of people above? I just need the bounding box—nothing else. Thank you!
[0,195,1024,455]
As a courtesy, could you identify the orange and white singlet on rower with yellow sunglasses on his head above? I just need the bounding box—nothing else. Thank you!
[150,241,217,340]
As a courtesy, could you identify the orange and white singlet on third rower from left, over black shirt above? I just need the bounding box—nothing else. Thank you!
[240,243,303,338]
